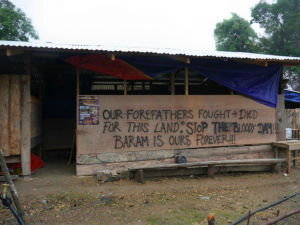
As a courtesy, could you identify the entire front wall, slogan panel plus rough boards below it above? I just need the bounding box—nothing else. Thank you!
[77,95,278,175]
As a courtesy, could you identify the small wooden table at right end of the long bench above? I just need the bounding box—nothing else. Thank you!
[273,140,300,173]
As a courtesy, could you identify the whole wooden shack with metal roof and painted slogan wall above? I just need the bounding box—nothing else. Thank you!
[0,41,300,175]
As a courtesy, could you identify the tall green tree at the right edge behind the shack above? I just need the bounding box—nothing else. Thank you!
[251,0,300,91]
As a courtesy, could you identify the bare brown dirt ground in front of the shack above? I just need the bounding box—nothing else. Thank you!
[0,159,300,225]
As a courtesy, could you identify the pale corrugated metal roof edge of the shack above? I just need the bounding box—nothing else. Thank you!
[0,41,300,61]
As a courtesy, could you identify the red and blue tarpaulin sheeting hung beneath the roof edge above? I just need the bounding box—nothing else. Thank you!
[64,54,281,108]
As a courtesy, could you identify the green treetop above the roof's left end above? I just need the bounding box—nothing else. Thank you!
[0,0,39,41]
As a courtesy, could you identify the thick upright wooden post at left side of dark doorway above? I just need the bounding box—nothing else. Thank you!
[21,55,31,177]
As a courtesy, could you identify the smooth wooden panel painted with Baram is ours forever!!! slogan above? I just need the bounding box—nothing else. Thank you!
[77,95,277,154]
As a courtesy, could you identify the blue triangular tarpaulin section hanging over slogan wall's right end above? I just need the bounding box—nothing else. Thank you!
[190,59,281,108]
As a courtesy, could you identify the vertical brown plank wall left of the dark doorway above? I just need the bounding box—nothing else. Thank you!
[0,75,42,161]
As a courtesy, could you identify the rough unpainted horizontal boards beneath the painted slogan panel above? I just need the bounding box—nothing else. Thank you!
[76,145,274,176]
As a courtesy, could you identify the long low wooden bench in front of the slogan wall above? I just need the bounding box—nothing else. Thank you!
[128,158,286,183]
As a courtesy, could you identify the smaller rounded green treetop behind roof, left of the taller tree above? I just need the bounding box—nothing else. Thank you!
[214,13,258,52]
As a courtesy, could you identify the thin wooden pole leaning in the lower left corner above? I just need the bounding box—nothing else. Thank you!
[0,145,26,221]
